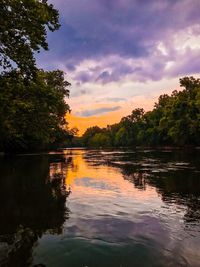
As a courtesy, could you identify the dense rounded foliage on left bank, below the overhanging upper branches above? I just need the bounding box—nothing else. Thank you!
[0,70,70,151]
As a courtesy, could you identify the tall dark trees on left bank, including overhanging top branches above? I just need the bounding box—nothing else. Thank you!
[0,0,71,152]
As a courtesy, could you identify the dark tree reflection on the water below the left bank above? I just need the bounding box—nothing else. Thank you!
[0,155,71,267]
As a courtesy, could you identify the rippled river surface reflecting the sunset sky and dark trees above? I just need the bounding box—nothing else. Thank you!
[0,149,200,267]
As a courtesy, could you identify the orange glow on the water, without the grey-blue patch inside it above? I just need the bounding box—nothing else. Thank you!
[65,149,157,200]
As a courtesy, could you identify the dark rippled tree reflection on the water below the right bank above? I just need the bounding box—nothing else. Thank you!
[99,151,200,224]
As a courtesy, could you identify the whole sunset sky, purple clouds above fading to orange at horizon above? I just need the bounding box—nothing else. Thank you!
[37,0,200,135]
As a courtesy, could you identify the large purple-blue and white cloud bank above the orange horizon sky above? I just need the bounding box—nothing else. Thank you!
[36,0,200,85]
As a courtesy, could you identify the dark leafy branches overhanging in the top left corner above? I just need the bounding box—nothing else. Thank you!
[0,0,60,76]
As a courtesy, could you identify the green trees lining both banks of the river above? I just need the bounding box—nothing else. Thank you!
[0,0,200,152]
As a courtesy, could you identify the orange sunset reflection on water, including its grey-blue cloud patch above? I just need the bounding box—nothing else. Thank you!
[65,150,158,201]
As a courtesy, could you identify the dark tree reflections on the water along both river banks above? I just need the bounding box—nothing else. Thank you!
[0,151,200,267]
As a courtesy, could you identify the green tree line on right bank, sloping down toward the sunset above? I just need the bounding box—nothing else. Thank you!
[74,77,200,147]
